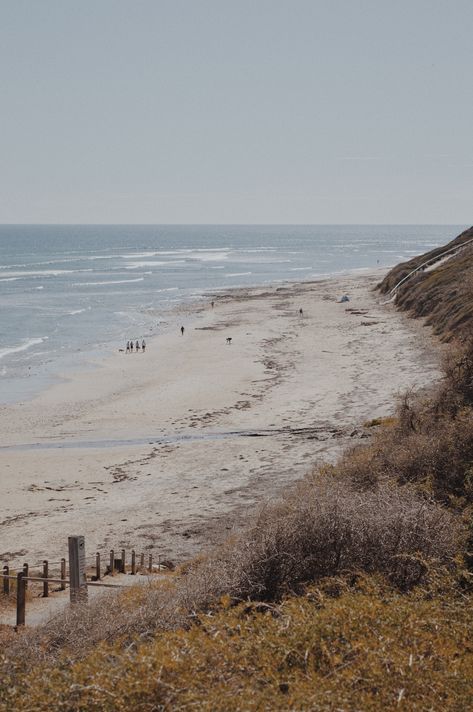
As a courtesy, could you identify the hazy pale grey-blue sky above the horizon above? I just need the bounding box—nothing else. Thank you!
[0,0,473,224]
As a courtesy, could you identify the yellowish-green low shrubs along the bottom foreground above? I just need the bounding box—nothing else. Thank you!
[0,577,473,712]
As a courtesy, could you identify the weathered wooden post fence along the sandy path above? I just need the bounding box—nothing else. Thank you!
[0,536,161,626]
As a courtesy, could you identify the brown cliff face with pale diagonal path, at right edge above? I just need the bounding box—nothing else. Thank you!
[378,227,473,341]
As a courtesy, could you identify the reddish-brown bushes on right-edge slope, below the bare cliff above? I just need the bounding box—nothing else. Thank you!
[338,340,473,516]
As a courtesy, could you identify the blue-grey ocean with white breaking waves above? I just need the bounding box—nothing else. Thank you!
[0,225,464,403]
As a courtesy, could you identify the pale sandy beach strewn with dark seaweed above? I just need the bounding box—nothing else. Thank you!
[0,271,438,565]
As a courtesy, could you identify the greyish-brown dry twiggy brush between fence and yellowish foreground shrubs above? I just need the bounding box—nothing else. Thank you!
[2,474,462,664]
